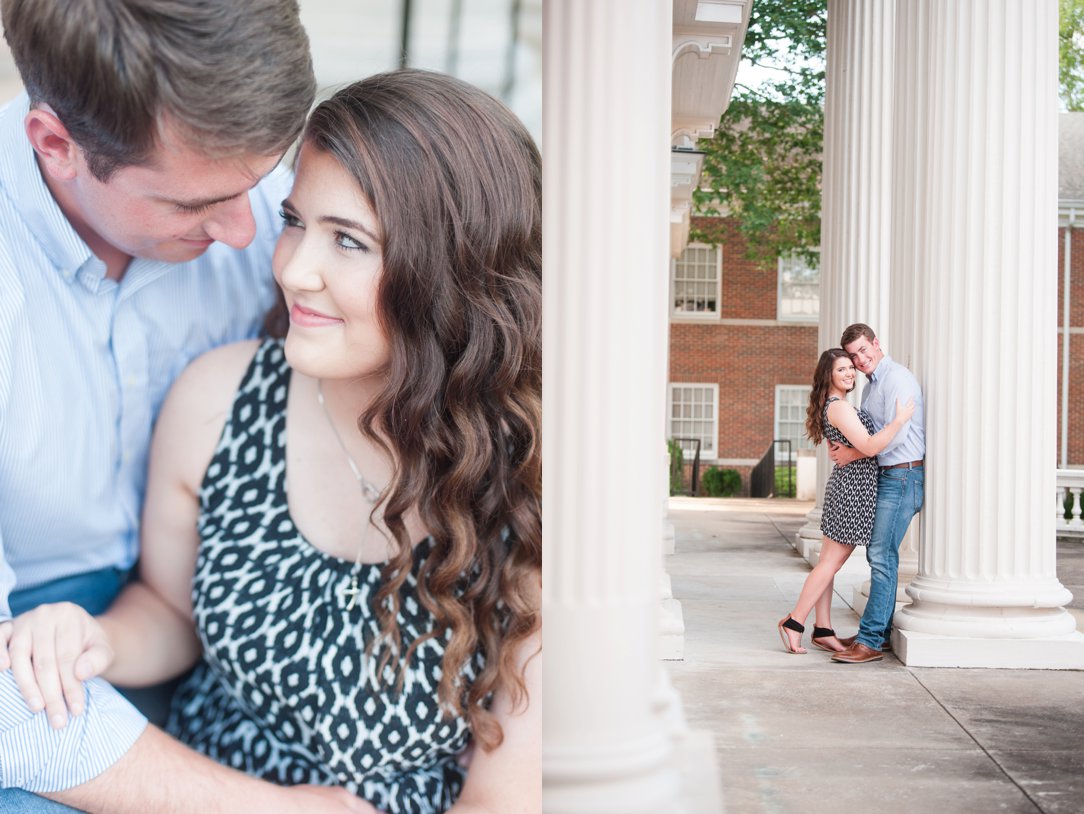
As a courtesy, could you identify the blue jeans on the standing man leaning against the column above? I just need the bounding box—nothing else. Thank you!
[855,467,926,650]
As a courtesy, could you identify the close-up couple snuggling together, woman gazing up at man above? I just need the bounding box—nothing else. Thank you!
[0,0,542,814]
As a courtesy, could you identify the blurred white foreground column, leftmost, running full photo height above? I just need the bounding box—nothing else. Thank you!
[542,0,680,814]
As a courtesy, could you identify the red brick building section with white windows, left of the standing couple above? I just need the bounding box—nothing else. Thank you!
[667,219,820,494]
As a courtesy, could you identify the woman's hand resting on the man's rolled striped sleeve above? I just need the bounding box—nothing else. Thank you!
[0,602,113,729]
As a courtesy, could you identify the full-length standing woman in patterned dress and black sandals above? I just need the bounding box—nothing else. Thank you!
[777,348,915,654]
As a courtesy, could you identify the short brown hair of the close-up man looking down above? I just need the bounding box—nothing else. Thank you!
[0,0,315,181]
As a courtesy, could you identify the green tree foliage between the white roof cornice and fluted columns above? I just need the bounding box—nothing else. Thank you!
[692,0,827,266]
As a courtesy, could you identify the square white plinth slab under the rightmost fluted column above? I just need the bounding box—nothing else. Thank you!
[892,628,1084,670]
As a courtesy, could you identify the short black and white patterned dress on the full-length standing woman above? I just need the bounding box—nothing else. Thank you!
[821,398,880,545]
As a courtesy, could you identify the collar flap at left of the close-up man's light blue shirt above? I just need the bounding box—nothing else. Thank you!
[0,92,93,283]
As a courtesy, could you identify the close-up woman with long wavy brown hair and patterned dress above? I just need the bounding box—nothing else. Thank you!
[0,70,542,814]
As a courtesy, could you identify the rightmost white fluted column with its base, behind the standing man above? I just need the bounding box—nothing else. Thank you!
[893,0,1084,668]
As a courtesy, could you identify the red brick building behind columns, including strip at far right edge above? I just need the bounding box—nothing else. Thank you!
[667,113,1084,494]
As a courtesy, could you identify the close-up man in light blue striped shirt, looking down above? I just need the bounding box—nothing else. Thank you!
[0,0,367,812]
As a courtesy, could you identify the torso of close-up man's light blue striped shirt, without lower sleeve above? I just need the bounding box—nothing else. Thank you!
[0,95,289,613]
